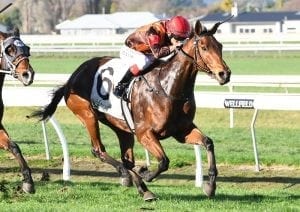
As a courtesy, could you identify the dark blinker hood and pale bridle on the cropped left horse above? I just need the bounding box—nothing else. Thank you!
[0,36,30,78]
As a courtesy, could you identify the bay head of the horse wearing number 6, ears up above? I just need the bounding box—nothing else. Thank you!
[186,17,231,85]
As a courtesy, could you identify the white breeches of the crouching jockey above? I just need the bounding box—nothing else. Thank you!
[120,45,154,70]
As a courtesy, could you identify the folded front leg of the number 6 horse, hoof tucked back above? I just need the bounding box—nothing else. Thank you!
[134,130,170,182]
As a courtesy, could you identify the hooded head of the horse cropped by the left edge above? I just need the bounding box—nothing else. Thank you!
[0,29,34,86]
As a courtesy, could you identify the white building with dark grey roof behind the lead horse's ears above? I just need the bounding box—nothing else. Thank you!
[199,7,300,34]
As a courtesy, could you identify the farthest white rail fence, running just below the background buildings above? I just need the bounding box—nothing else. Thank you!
[21,34,300,53]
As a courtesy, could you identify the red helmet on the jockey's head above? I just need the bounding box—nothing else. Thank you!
[166,16,191,38]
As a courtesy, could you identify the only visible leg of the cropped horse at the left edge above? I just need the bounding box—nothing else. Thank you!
[0,129,35,193]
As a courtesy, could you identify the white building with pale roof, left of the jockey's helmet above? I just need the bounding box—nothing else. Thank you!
[55,12,161,35]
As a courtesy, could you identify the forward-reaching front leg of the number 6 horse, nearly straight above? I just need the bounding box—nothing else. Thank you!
[175,124,218,197]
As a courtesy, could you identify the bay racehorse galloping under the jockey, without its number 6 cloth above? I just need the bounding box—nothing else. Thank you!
[29,20,231,200]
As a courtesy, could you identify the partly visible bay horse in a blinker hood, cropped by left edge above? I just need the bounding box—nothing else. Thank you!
[0,29,35,193]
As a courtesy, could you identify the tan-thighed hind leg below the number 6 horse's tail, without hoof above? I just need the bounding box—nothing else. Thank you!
[67,94,130,186]
